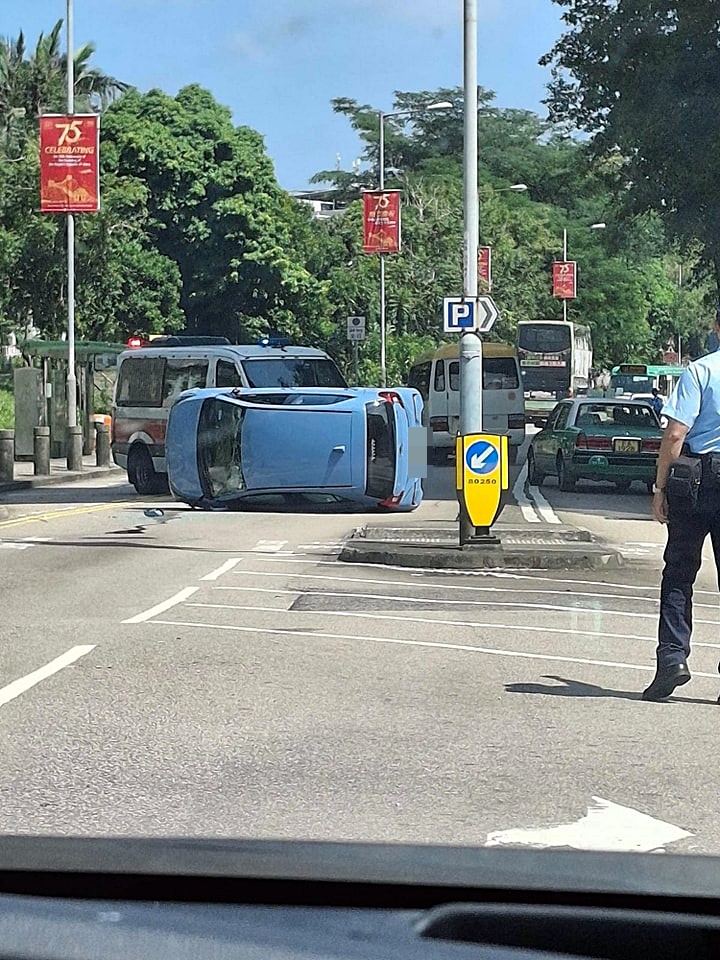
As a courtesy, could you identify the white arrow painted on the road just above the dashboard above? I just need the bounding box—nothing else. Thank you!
[485,797,693,853]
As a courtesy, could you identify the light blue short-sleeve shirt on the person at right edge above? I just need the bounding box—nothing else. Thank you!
[662,350,720,453]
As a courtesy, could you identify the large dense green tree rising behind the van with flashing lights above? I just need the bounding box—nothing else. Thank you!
[103,86,327,342]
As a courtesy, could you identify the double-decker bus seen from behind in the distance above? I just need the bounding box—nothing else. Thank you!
[517,320,592,422]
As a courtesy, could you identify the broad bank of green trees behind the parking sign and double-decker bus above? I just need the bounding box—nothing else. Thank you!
[314,88,707,378]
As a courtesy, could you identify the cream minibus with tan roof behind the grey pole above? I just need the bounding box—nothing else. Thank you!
[407,343,525,463]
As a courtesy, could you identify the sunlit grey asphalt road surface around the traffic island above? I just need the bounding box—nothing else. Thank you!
[0,454,720,854]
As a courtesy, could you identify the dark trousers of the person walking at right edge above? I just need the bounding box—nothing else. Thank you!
[657,477,720,666]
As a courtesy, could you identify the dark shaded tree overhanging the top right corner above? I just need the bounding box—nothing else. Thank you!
[541,0,720,290]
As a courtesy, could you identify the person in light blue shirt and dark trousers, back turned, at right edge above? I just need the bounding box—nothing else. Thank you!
[642,311,720,700]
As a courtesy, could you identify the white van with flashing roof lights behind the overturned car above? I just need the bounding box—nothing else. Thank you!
[112,336,347,494]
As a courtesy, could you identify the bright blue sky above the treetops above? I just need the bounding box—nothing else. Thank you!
[0,0,561,190]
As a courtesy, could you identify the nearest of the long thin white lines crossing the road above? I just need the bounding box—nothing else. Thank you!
[146,620,718,680]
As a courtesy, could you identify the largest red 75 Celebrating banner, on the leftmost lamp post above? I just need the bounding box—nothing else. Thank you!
[40,113,100,213]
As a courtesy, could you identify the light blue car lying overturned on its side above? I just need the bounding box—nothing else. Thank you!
[166,387,427,511]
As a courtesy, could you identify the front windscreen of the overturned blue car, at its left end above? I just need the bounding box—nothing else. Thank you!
[197,398,245,497]
